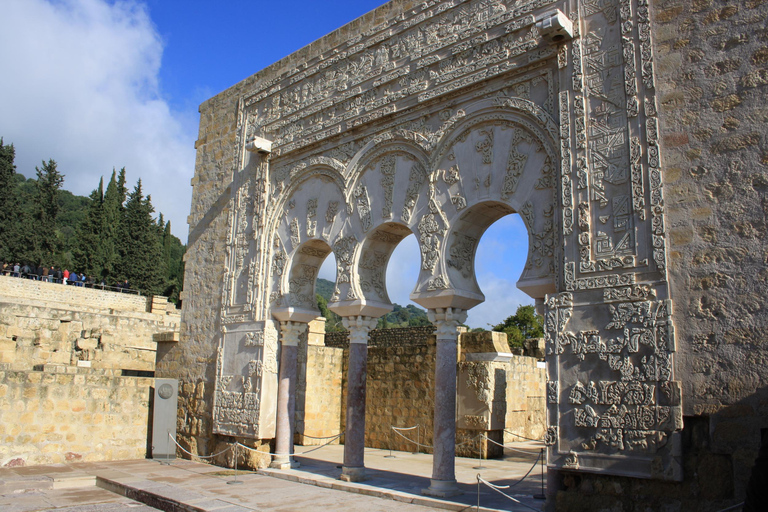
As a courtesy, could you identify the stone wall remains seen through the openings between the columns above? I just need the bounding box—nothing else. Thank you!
[308,326,546,457]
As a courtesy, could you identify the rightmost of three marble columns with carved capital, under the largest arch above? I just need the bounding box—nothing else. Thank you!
[422,308,467,498]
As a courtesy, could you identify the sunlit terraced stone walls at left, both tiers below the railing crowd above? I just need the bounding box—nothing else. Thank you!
[0,277,180,465]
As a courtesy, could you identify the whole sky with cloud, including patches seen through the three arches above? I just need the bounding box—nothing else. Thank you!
[0,0,531,327]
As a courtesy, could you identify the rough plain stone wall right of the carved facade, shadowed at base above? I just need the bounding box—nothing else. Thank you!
[557,0,768,511]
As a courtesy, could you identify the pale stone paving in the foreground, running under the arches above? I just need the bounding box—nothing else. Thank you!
[0,443,544,512]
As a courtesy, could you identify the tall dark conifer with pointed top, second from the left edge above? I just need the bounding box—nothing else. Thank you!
[34,159,64,263]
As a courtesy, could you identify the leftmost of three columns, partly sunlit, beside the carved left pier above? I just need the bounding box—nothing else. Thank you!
[269,321,307,469]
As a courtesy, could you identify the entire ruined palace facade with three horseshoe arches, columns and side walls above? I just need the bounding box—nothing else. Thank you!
[166,0,768,510]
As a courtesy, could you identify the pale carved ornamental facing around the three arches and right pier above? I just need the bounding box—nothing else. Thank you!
[204,0,682,479]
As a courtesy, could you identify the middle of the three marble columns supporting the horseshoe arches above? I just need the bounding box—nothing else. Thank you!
[340,316,378,482]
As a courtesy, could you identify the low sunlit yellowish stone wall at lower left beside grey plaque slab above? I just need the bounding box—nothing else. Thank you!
[0,365,154,466]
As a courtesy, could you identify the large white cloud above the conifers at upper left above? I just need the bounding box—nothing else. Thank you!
[0,0,197,241]
